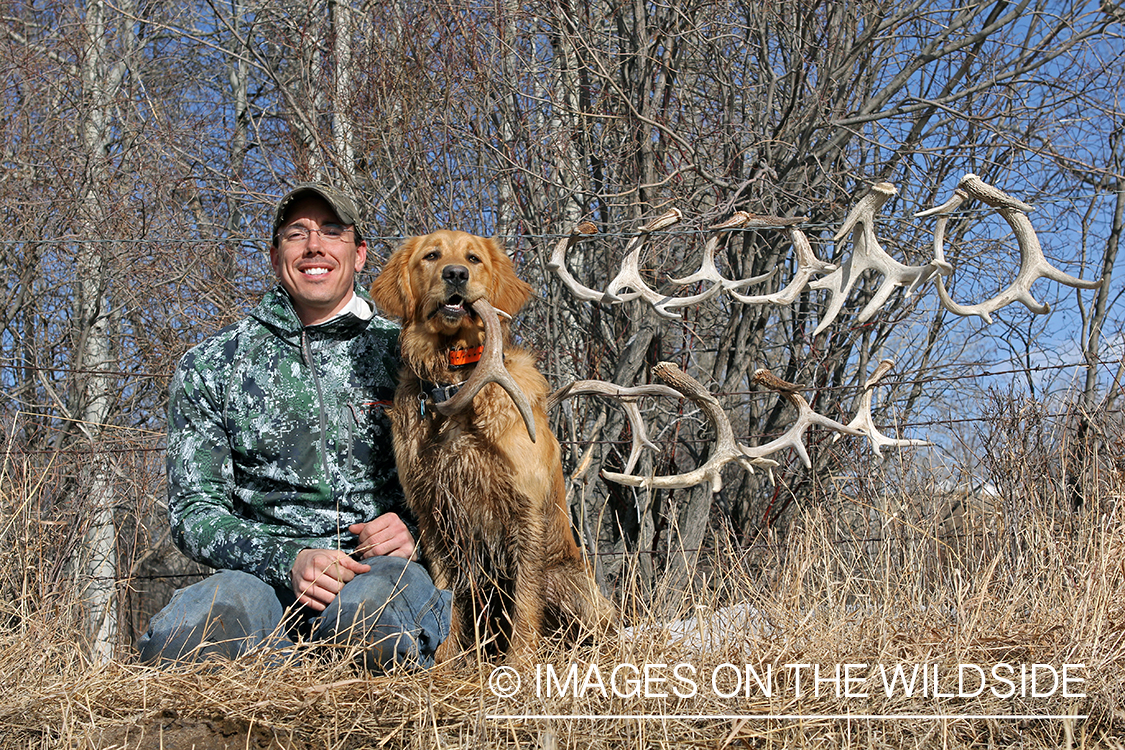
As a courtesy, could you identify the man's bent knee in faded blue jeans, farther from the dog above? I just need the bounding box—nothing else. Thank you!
[137,570,281,661]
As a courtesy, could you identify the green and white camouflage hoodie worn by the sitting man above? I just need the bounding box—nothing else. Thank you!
[168,287,416,588]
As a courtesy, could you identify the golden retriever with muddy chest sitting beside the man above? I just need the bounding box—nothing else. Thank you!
[371,231,617,663]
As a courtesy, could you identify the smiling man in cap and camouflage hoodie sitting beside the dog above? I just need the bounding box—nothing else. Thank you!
[137,184,449,667]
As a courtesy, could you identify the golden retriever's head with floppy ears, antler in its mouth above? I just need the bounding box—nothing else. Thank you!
[371,229,531,336]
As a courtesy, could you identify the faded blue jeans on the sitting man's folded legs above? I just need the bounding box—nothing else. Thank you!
[137,557,450,669]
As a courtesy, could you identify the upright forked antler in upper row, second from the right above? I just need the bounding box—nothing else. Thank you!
[809,182,953,335]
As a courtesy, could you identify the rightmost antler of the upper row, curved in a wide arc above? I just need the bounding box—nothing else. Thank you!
[932,174,1104,324]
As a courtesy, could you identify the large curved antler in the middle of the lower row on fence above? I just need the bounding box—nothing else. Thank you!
[602,362,776,493]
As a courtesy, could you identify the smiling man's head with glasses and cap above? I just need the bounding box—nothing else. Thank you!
[270,196,367,325]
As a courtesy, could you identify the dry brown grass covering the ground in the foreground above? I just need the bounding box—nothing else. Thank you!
[0,443,1125,750]
